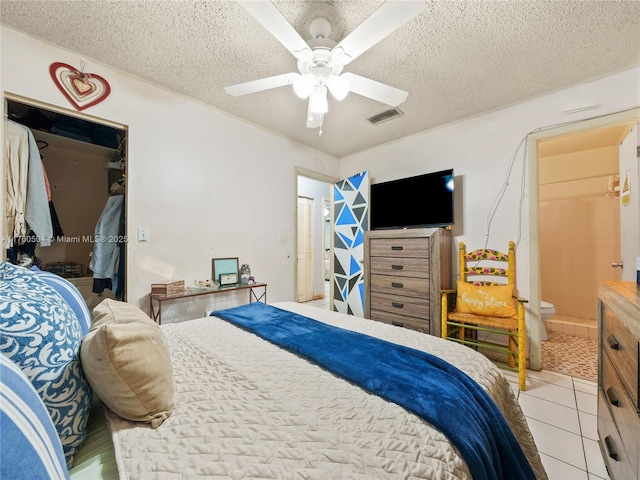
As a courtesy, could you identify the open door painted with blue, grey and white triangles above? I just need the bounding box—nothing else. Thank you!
[331,172,369,317]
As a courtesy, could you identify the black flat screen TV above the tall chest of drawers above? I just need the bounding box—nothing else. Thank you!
[369,169,454,230]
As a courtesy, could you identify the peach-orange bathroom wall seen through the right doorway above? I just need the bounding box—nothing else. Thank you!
[539,146,620,320]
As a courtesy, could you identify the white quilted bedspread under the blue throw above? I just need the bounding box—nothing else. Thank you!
[108,303,546,480]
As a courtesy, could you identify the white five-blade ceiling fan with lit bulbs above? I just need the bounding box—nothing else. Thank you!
[225,0,426,134]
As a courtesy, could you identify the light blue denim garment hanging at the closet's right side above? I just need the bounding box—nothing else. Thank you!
[89,195,124,293]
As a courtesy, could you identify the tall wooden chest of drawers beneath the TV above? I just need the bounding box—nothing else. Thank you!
[364,228,451,336]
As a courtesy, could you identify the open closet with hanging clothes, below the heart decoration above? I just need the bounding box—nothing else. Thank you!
[3,98,127,308]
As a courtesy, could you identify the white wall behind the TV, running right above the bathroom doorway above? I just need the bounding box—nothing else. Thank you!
[340,68,640,296]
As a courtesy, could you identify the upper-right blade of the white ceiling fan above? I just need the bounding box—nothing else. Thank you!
[332,0,427,65]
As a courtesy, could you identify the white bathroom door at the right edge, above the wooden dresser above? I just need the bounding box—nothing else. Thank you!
[612,125,640,282]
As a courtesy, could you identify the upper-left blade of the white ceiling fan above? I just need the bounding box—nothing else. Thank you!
[239,0,313,60]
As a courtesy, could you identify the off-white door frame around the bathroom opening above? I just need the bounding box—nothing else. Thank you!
[527,108,640,370]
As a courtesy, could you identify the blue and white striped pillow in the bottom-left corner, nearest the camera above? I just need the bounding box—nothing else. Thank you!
[0,353,69,480]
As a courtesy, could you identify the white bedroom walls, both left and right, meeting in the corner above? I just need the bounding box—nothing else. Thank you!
[0,26,640,320]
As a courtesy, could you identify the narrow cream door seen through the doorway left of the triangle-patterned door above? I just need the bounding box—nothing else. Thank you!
[297,197,313,302]
